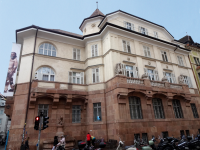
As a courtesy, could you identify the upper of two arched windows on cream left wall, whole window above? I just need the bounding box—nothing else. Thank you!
[38,43,56,57]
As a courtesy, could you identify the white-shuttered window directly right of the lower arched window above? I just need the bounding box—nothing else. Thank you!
[69,71,84,84]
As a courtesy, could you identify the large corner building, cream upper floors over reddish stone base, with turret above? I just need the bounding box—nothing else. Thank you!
[5,9,199,149]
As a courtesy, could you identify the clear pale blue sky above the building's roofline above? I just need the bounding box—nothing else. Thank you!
[0,0,200,93]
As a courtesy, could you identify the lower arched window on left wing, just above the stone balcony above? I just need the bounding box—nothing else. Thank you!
[35,67,55,81]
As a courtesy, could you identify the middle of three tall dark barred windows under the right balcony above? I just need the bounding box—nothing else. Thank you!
[153,98,165,119]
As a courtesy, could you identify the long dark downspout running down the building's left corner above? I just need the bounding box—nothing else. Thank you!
[22,27,38,143]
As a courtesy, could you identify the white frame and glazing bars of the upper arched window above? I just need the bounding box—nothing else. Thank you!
[38,43,57,57]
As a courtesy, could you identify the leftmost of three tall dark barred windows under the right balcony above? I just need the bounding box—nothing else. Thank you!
[129,97,142,119]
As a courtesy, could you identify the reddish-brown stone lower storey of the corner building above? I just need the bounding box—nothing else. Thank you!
[5,76,200,150]
